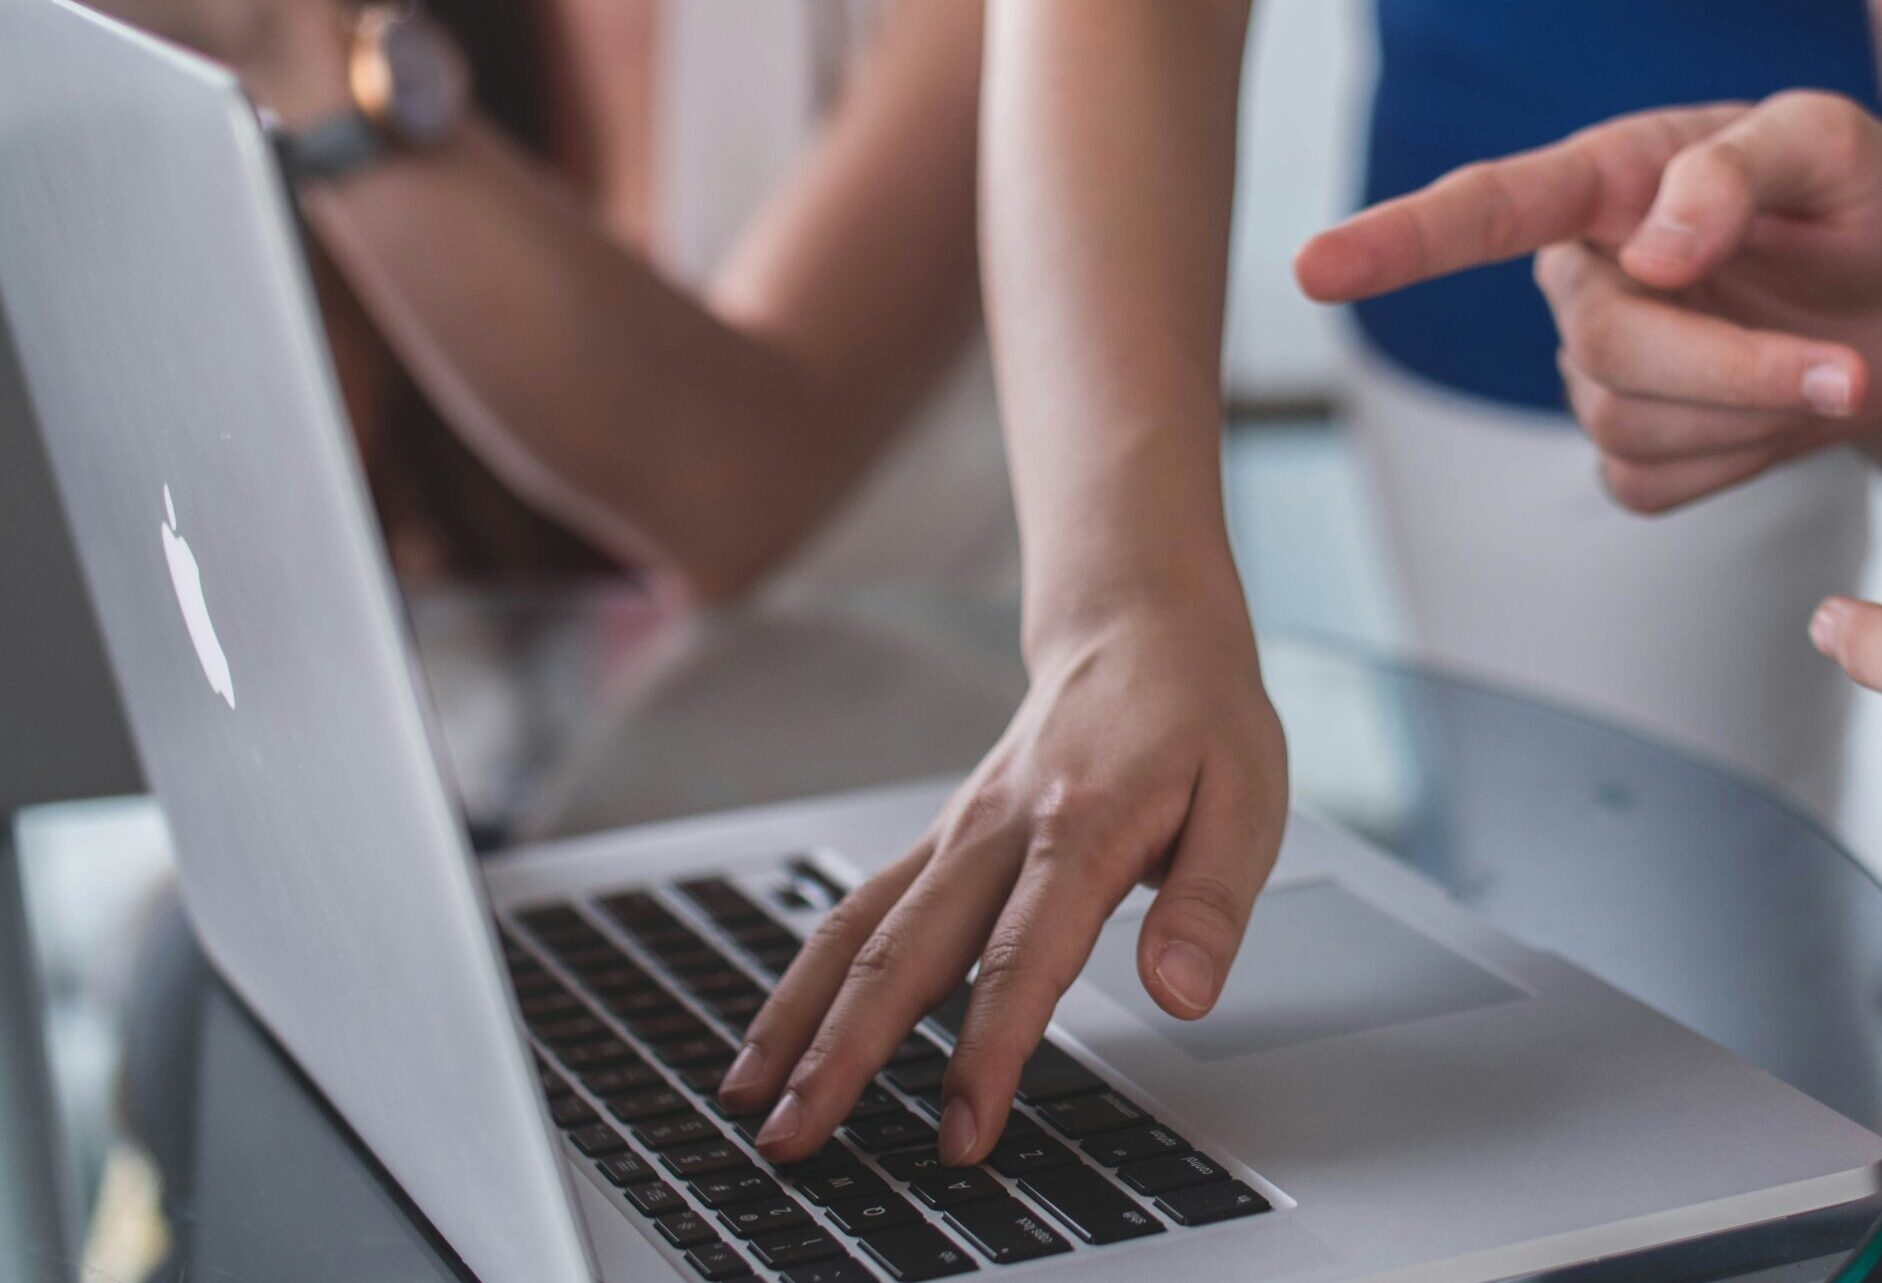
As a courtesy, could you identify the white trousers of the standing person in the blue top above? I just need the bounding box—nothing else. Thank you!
[1349,344,1869,818]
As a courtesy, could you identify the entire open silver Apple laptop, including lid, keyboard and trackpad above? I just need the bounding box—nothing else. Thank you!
[0,0,1882,1283]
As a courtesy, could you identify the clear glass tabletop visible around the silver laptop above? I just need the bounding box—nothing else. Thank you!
[11,593,1882,1281]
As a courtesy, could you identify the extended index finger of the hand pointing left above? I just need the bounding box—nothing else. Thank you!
[1295,105,1745,303]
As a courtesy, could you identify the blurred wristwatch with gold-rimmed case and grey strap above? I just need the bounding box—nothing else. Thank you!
[280,4,471,182]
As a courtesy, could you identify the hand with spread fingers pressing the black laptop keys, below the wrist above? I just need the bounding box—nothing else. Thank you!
[721,608,1287,1164]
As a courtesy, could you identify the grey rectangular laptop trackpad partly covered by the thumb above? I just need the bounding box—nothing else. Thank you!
[1086,880,1526,1061]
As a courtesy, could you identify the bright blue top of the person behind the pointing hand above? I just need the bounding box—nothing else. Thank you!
[1355,0,1876,410]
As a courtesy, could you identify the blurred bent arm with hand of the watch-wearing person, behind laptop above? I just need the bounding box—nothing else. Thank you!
[106,0,981,598]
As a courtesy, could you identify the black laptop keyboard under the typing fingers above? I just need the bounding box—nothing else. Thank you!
[502,865,1268,1283]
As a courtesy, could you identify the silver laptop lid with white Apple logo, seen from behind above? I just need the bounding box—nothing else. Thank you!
[0,0,593,1283]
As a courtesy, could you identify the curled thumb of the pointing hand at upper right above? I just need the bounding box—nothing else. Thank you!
[1620,92,1882,290]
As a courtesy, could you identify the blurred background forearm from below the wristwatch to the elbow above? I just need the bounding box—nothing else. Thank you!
[307,126,861,593]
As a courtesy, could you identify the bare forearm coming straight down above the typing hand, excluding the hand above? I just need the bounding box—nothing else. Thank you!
[982,0,1248,647]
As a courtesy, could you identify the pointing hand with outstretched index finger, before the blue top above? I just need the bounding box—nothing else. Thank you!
[1297,92,1882,512]
